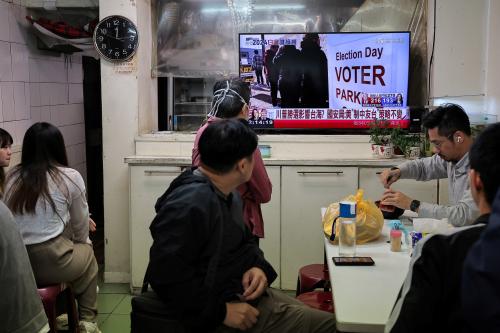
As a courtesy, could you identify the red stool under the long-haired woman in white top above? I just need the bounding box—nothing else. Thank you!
[38,283,80,333]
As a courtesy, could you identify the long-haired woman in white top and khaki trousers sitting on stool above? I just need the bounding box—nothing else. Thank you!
[5,123,100,332]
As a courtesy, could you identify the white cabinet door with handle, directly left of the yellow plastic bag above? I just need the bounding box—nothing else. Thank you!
[281,166,358,290]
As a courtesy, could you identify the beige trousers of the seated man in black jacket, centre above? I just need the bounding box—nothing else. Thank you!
[216,288,335,333]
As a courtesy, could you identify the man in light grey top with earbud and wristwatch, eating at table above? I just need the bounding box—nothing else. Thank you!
[380,104,479,226]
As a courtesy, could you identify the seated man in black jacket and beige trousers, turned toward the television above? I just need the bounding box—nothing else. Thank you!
[147,120,335,333]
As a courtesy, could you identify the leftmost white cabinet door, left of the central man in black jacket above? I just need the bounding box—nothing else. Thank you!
[129,166,186,288]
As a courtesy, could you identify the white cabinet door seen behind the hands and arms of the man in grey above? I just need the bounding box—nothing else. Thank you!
[359,167,437,203]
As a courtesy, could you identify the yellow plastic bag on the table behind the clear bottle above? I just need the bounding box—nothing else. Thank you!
[323,189,384,244]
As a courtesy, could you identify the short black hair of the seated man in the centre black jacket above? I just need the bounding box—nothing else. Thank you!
[198,119,258,173]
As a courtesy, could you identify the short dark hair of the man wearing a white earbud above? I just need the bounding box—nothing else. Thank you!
[423,103,471,136]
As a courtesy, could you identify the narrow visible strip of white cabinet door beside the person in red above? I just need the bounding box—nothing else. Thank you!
[259,166,281,288]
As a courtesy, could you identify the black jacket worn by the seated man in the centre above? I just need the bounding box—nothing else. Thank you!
[147,169,276,331]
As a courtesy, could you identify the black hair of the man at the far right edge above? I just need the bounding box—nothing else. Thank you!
[469,123,500,205]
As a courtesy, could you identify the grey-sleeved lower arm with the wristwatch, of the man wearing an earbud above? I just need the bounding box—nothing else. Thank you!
[418,189,479,227]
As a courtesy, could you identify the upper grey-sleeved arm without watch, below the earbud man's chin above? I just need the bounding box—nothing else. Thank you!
[398,154,448,181]
